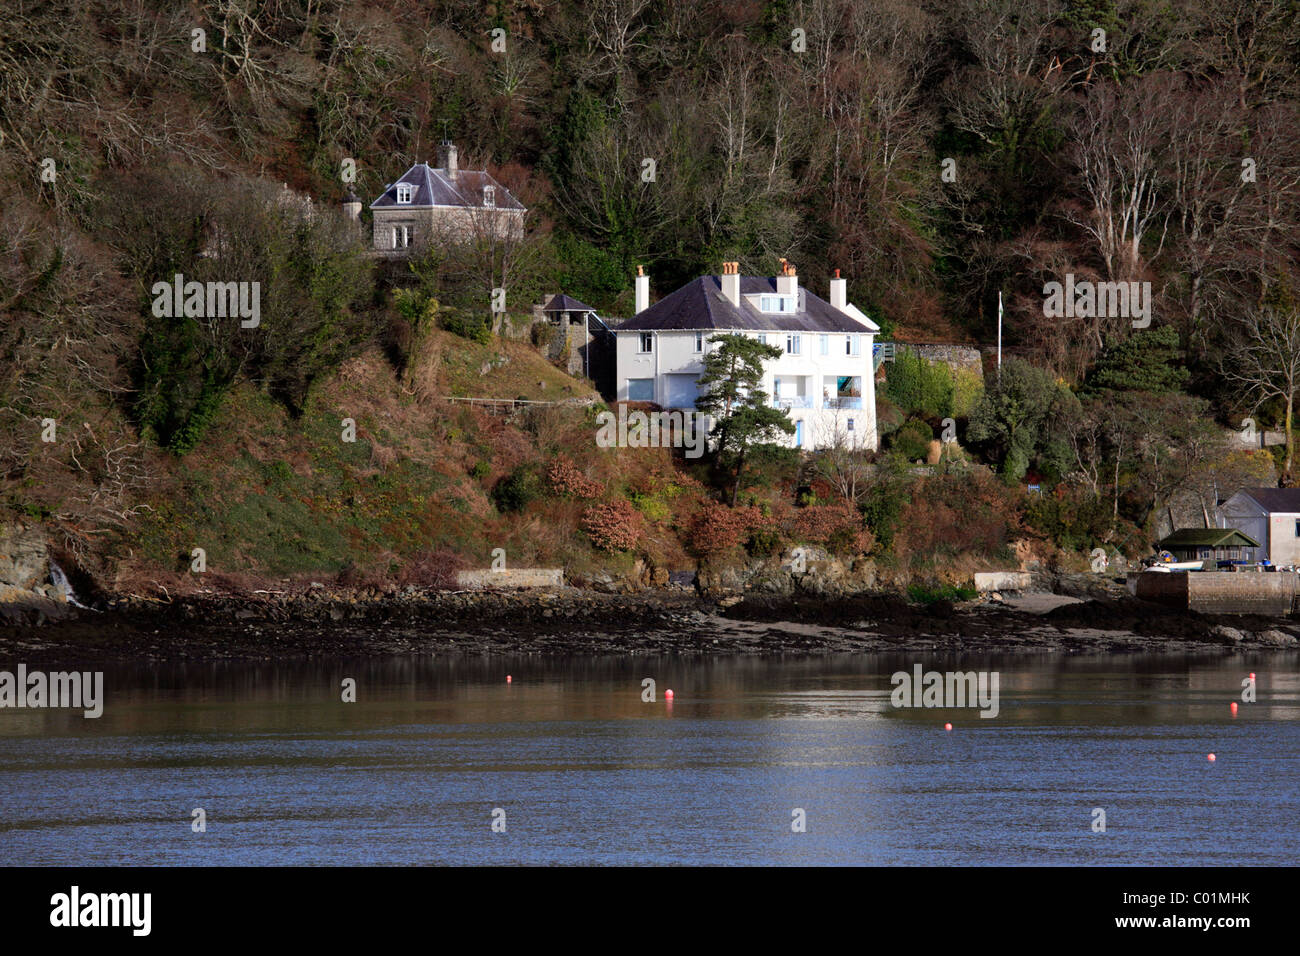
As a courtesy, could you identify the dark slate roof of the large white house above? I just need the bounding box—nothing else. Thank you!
[615,276,880,333]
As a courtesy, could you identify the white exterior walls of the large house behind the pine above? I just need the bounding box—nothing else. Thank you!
[615,330,879,451]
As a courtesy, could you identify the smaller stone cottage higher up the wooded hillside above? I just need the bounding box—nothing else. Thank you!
[364,143,528,255]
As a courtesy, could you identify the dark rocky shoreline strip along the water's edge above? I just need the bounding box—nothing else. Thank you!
[0,588,1300,665]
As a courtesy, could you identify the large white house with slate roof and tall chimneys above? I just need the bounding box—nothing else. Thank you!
[615,259,880,450]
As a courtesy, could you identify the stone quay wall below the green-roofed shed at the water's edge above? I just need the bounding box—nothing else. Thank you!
[1131,571,1300,617]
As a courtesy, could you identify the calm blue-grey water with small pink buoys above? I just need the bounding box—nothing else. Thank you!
[0,654,1300,865]
